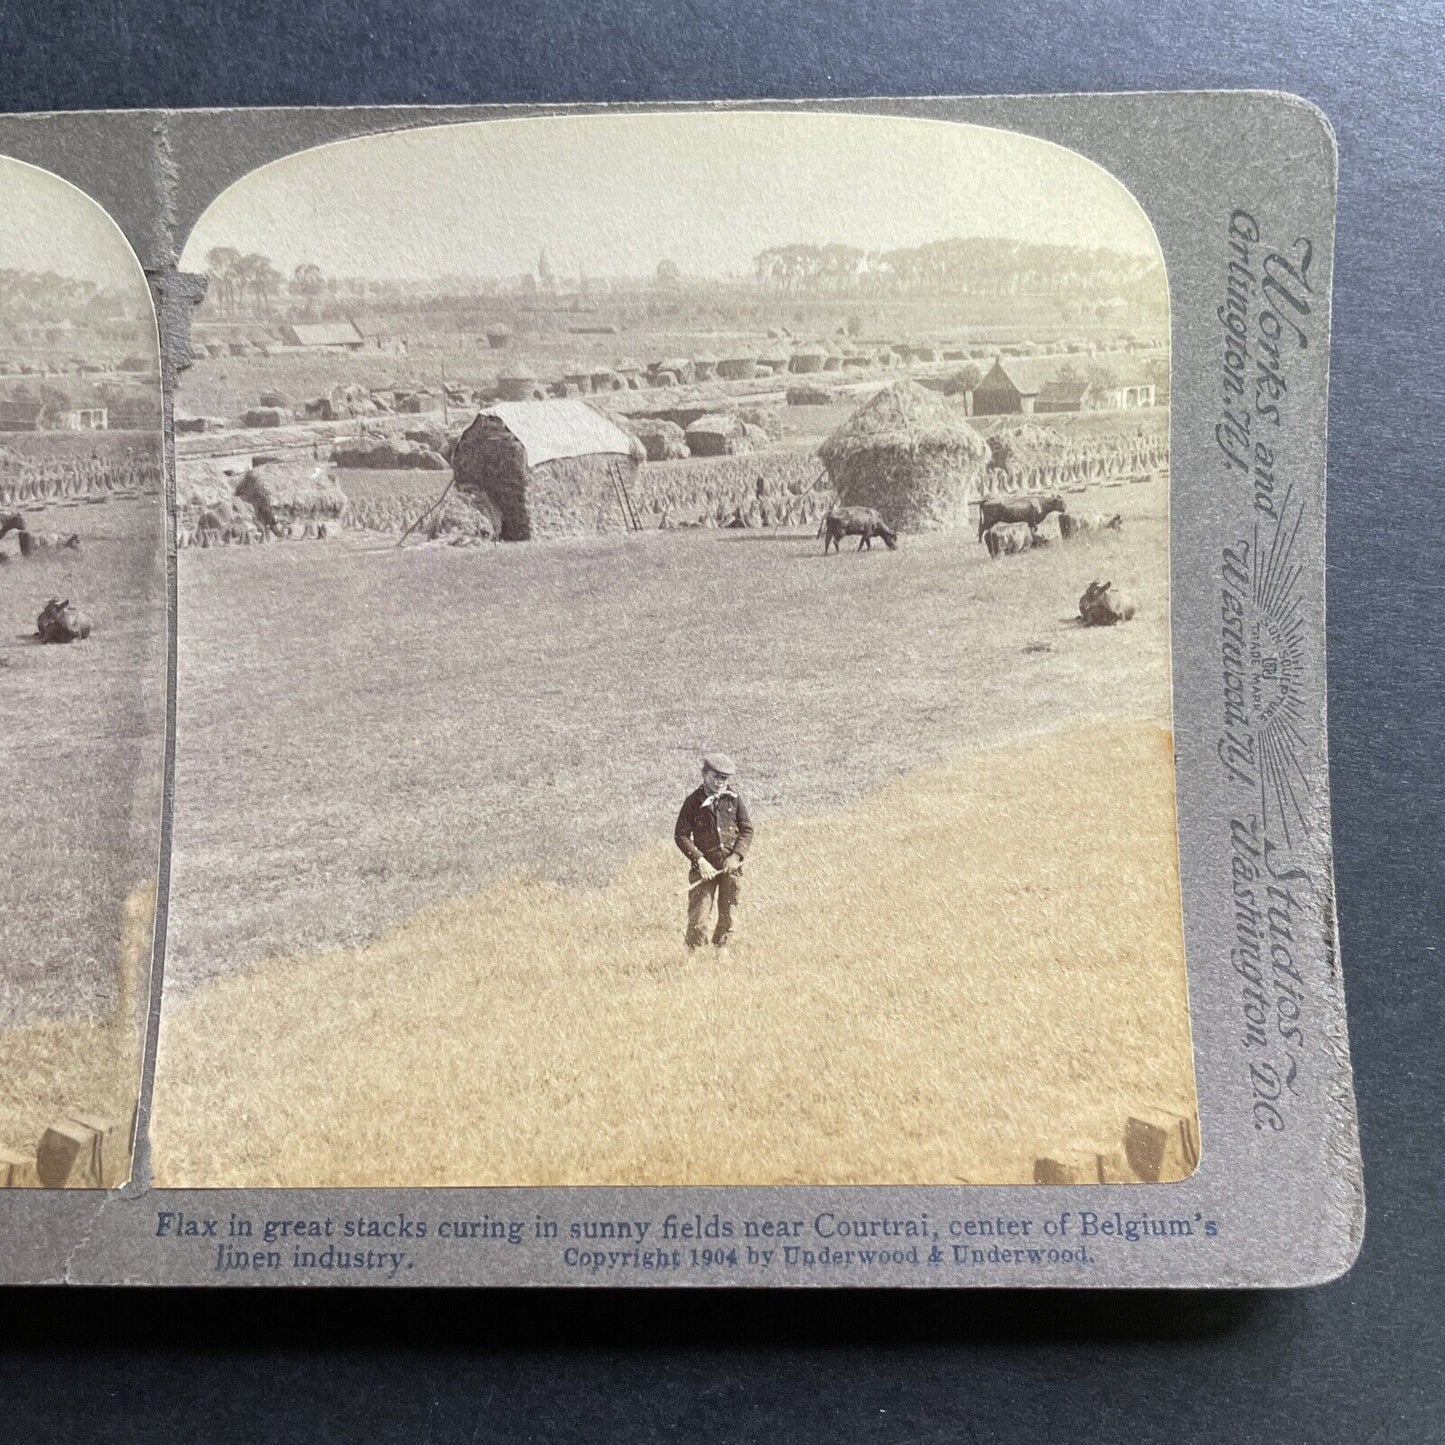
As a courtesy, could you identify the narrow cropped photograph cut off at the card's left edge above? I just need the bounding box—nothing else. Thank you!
[0,158,166,1188]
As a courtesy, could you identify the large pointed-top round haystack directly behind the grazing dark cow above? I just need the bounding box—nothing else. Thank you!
[818,381,988,532]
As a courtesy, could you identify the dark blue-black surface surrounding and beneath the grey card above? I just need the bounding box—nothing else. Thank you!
[0,0,1445,1445]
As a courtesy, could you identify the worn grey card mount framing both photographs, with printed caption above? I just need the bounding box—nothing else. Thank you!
[0,91,1364,1287]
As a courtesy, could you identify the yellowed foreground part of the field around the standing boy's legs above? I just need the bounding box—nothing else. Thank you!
[153,723,1194,1188]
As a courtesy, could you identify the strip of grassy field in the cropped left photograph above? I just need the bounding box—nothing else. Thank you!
[0,496,166,1147]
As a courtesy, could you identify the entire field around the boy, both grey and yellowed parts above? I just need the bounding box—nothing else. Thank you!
[155,483,1192,1185]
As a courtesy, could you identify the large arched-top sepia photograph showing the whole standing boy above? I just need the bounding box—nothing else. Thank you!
[152,111,1199,1188]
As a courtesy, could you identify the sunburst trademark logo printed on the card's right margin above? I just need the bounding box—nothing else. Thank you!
[1218,494,1314,844]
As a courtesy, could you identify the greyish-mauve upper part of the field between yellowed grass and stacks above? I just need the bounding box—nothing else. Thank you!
[166,483,1170,991]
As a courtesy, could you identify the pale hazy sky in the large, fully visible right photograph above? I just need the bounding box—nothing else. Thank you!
[181,111,1159,279]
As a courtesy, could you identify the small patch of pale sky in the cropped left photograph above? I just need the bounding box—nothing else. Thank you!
[0,156,150,289]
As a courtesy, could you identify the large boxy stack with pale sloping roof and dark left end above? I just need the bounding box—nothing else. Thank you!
[452,400,646,542]
